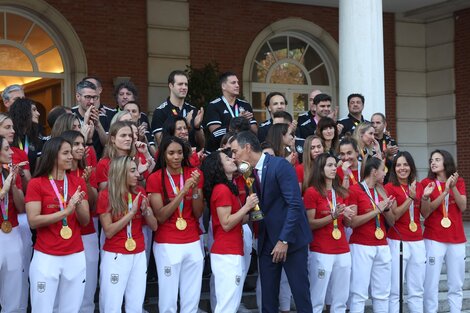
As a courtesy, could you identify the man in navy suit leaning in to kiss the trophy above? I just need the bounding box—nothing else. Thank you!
[231,131,312,313]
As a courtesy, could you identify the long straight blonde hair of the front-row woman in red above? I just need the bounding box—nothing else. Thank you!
[108,156,135,216]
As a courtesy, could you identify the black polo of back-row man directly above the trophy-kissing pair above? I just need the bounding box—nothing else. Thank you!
[203,97,257,152]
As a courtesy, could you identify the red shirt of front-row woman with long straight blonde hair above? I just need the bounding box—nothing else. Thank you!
[96,186,145,254]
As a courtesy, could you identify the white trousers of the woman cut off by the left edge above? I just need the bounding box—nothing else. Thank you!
[0,227,23,313]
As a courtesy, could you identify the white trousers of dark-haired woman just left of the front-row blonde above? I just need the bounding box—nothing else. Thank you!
[29,250,86,313]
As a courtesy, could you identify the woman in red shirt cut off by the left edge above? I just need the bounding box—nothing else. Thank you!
[0,136,24,312]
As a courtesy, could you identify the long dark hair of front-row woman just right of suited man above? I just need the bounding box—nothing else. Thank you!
[308,153,348,198]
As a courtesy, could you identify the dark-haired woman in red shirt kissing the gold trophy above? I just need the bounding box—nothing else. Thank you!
[203,151,258,313]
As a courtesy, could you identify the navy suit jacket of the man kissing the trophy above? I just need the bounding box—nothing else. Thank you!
[258,155,312,253]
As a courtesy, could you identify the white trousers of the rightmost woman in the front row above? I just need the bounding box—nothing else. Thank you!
[424,239,465,313]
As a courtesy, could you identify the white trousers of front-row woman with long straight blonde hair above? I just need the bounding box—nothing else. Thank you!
[100,251,148,313]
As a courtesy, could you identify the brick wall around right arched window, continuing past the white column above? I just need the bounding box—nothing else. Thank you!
[189,0,396,136]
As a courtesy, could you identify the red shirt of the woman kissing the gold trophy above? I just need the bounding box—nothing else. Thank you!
[211,184,243,255]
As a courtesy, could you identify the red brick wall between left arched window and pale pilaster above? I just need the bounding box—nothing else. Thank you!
[46,0,148,111]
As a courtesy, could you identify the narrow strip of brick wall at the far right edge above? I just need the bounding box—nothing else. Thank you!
[454,9,470,221]
